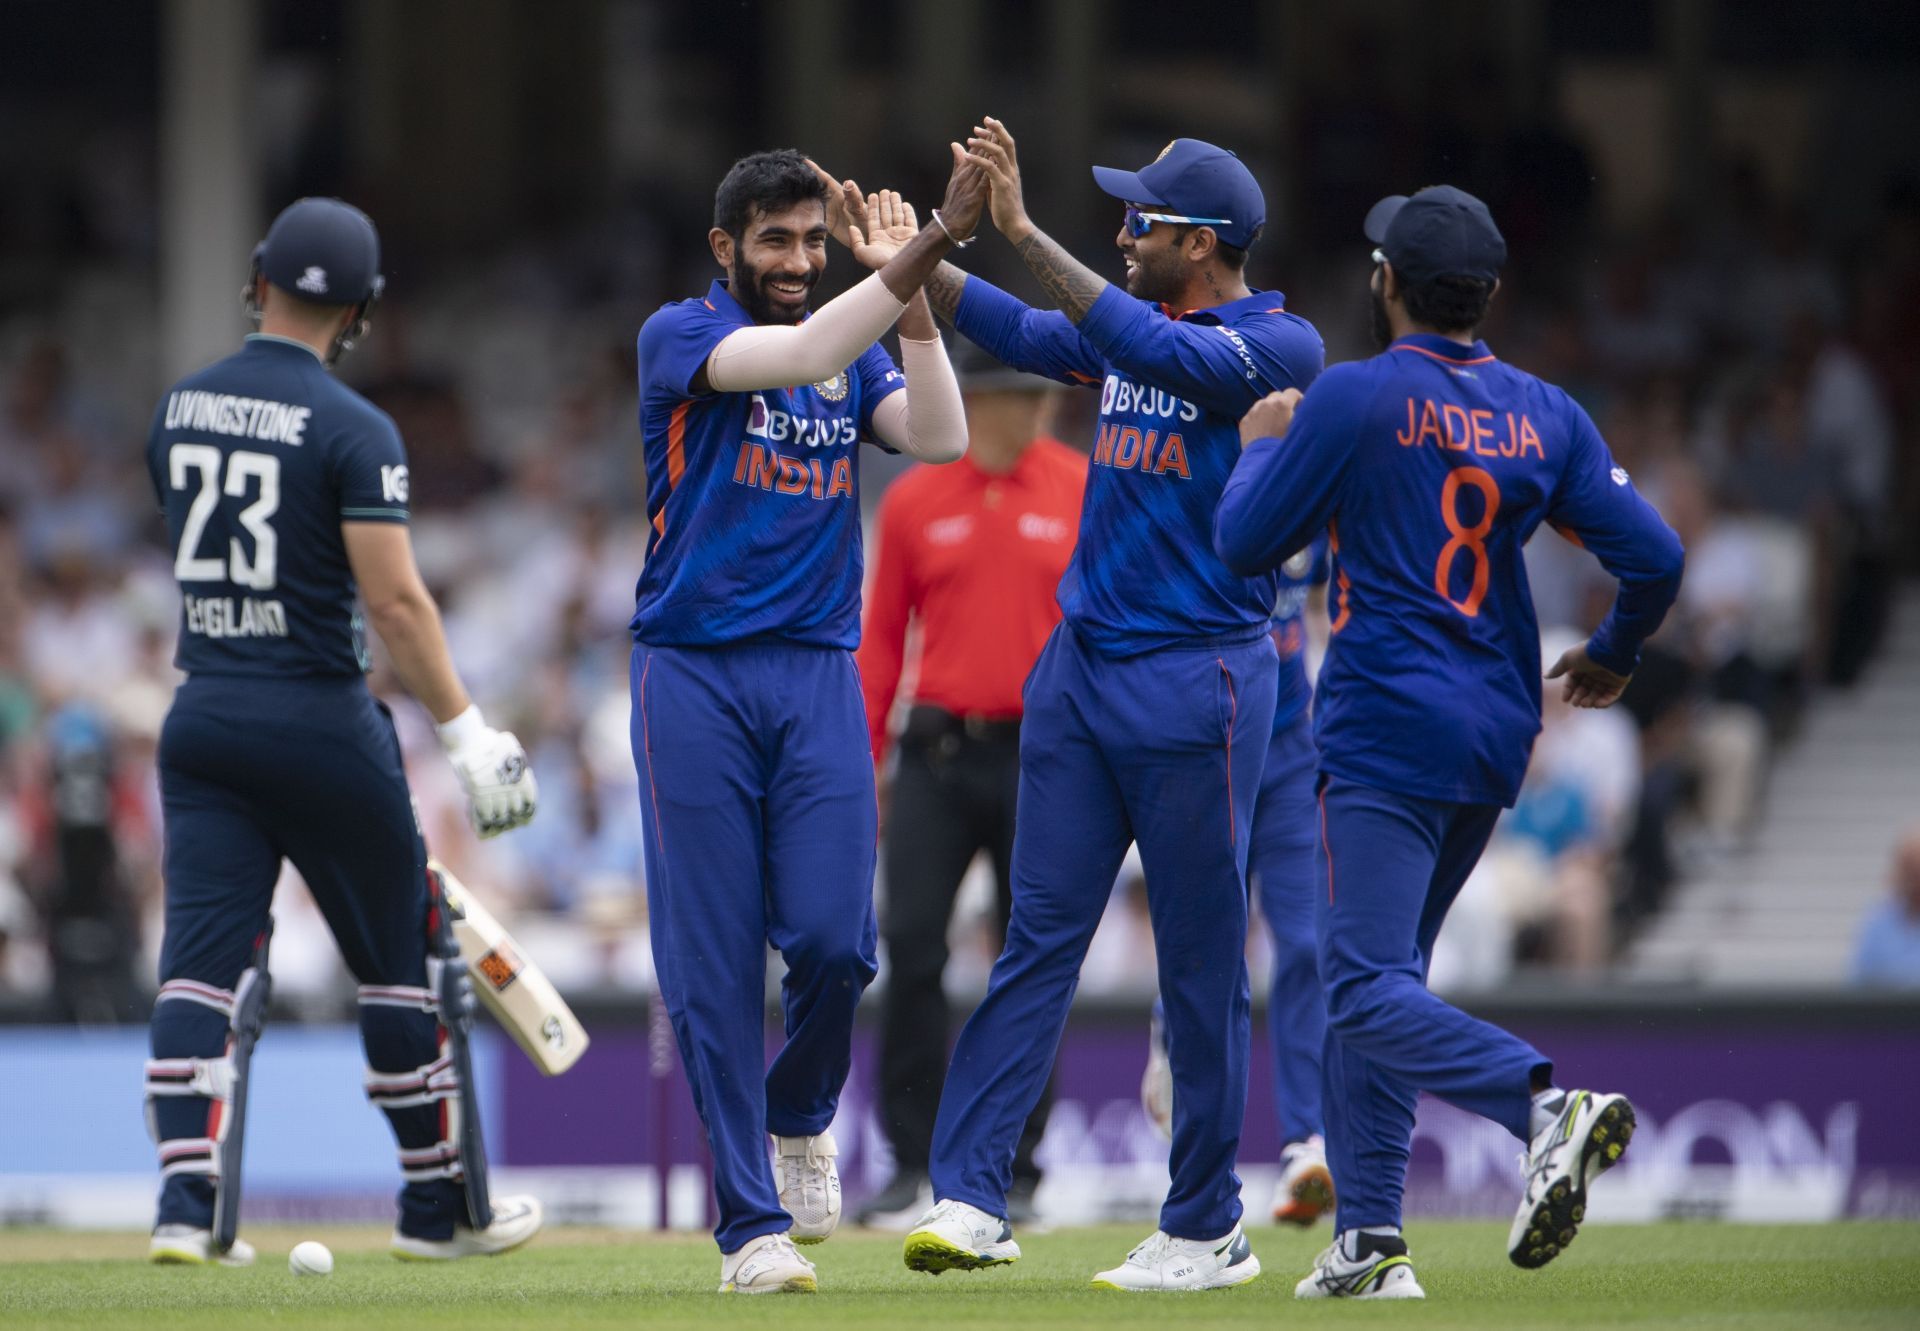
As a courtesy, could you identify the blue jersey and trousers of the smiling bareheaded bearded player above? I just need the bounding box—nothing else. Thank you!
[632,282,906,1252]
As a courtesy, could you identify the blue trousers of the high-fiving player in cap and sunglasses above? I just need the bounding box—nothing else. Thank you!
[931,626,1277,1239]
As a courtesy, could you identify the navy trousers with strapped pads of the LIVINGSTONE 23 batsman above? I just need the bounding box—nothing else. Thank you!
[148,676,467,1239]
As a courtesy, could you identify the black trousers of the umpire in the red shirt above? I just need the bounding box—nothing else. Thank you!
[879,707,1054,1183]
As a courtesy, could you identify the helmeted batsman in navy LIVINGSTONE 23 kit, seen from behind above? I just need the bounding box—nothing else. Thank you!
[146,198,541,1266]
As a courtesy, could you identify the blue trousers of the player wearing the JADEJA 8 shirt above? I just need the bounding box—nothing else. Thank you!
[1317,776,1551,1231]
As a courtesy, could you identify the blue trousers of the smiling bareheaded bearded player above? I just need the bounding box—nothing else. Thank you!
[632,643,879,1252]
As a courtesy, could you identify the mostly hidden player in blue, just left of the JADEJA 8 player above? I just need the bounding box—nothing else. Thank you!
[1140,538,1332,1227]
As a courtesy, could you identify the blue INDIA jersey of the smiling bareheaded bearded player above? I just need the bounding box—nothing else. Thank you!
[632,282,906,651]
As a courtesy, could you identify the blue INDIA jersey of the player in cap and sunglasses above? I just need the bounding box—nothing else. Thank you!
[954,277,1325,657]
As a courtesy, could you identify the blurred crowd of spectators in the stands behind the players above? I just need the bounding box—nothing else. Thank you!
[0,5,1920,1022]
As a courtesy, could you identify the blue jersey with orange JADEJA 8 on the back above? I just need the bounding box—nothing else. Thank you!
[1215,334,1682,805]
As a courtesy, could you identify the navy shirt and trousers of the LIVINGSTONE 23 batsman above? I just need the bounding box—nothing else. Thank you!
[146,334,465,1239]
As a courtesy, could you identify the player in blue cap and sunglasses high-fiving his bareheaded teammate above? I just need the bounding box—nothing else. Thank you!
[906,117,1323,1289]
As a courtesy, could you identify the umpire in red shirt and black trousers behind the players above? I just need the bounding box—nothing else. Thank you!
[856,344,1087,1223]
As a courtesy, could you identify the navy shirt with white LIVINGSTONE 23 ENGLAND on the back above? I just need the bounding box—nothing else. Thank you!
[146,334,407,676]
